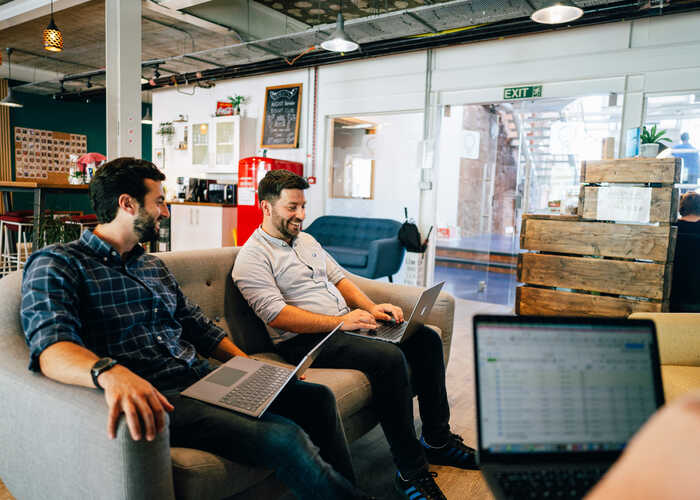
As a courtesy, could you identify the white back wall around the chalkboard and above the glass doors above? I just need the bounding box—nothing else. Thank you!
[153,13,700,233]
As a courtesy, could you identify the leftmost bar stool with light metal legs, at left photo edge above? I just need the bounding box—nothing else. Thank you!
[0,210,34,276]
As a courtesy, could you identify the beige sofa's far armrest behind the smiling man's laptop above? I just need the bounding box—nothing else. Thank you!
[345,271,455,366]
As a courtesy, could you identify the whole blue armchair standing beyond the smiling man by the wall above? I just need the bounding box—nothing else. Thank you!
[306,215,405,282]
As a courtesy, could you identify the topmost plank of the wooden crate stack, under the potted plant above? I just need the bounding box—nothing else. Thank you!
[581,158,681,184]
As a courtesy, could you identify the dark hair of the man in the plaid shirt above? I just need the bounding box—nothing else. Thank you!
[90,158,165,223]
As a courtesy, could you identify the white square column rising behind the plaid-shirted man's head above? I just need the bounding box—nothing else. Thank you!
[105,0,141,160]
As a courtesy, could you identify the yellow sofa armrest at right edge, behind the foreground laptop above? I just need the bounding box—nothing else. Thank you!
[629,312,700,366]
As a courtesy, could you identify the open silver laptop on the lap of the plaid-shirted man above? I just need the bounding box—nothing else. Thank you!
[182,323,343,418]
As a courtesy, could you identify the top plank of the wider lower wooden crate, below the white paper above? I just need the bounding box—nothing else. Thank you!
[520,215,676,262]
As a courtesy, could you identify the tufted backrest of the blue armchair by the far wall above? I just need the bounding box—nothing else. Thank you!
[305,215,401,248]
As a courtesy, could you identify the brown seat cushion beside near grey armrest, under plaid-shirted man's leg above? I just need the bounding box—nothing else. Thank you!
[170,447,272,500]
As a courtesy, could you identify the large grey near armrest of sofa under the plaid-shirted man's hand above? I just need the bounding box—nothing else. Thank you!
[0,325,175,500]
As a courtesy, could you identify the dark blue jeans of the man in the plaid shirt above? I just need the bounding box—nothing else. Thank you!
[167,381,359,500]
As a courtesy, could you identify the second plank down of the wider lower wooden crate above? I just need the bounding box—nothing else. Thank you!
[518,253,668,300]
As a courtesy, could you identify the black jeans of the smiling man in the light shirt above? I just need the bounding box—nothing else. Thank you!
[276,326,450,472]
